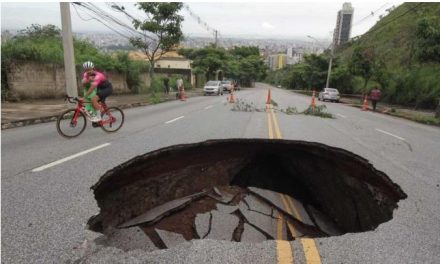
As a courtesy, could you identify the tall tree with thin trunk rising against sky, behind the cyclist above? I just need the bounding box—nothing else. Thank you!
[130,2,183,79]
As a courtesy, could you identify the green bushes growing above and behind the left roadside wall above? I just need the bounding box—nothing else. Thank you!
[1,25,148,99]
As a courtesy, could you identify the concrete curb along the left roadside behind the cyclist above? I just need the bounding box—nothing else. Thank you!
[1,94,200,130]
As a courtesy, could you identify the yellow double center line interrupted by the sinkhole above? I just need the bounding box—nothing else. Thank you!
[266,104,321,264]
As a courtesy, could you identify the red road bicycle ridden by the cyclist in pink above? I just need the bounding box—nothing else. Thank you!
[57,96,124,138]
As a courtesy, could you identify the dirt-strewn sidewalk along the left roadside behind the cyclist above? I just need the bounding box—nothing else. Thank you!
[1,89,203,130]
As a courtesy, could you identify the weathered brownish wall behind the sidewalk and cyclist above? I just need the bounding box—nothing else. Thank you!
[7,61,130,99]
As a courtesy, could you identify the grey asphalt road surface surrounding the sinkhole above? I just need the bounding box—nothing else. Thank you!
[1,84,440,264]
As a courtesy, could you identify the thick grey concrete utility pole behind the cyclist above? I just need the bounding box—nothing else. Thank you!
[60,2,78,97]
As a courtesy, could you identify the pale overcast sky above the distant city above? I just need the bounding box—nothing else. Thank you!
[1,1,402,40]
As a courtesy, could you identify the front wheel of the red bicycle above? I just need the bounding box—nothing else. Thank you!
[57,109,87,138]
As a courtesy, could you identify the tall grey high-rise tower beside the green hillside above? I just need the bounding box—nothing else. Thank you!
[333,3,354,46]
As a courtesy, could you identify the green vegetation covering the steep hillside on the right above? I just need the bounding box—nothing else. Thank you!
[266,3,440,109]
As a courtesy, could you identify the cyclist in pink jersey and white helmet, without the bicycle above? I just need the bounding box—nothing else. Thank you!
[82,61,113,122]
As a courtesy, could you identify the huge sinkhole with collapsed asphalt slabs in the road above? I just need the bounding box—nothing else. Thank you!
[88,139,406,248]
